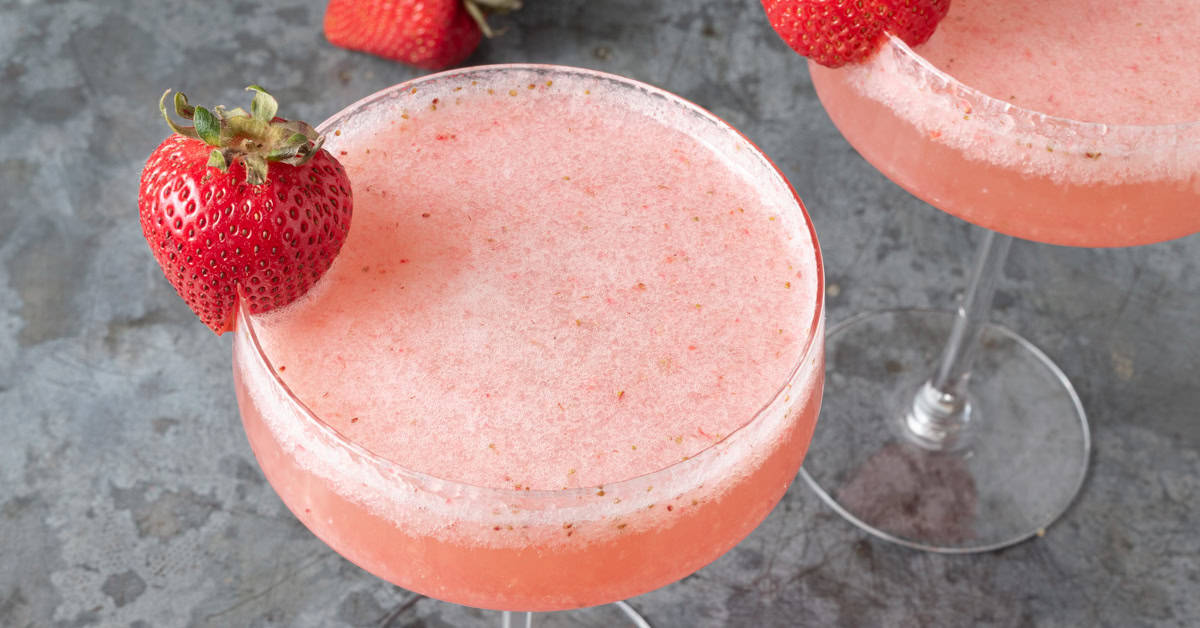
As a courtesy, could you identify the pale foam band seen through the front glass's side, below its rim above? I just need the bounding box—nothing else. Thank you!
[234,312,824,550]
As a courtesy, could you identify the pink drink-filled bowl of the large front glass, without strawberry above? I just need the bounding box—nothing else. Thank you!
[234,66,823,611]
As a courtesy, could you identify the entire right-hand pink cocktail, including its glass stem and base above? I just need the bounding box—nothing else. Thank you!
[805,0,1200,552]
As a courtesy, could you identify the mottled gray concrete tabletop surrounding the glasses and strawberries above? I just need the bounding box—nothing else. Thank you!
[0,0,1200,628]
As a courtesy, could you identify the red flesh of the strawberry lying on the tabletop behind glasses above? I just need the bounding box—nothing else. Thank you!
[324,0,482,70]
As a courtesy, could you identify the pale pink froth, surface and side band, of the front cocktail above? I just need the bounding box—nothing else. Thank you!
[245,65,820,549]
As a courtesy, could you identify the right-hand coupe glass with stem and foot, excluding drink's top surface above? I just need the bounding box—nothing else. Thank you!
[803,38,1200,552]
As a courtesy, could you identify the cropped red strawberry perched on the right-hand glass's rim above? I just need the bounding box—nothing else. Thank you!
[762,0,950,67]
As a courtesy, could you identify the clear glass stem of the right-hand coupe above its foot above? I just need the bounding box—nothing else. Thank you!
[905,231,1013,450]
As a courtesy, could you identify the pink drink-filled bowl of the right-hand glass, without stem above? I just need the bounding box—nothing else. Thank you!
[810,0,1200,246]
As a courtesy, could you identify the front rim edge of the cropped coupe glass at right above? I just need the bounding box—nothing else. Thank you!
[873,34,1200,137]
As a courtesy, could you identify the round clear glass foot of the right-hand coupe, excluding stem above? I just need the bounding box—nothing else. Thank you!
[800,310,1091,554]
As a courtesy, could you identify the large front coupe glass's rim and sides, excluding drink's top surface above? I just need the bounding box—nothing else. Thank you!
[226,66,824,626]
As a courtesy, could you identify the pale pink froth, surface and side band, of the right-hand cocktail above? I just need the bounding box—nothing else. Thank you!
[839,0,1200,185]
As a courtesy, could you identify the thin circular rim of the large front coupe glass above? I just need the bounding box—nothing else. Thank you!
[234,64,826,500]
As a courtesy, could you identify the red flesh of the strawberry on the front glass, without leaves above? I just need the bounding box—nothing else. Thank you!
[138,134,353,334]
